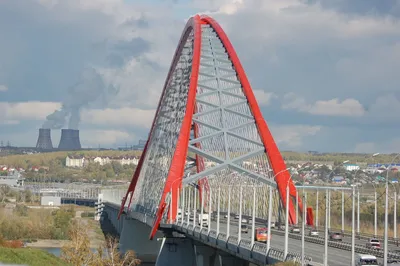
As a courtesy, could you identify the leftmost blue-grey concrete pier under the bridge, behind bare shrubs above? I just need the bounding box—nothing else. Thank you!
[119,215,163,264]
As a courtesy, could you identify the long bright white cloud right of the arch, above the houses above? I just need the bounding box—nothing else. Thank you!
[282,93,365,117]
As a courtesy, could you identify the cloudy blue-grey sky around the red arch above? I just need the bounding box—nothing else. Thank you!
[0,0,400,153]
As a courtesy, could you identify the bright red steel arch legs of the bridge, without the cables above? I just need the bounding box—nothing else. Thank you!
[120,15,302,239]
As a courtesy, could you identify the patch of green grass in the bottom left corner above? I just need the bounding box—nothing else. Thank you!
[0,247,68,266]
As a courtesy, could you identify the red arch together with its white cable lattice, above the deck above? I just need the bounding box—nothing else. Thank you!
[120,15,301,238]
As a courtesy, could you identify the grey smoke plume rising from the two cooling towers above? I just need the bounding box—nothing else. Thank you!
[42,67,118,129]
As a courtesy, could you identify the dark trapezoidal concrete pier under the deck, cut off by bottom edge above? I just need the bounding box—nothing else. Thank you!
[156,237,196,266]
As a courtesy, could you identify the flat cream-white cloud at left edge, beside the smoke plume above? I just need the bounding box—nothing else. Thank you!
[0,101,61,121]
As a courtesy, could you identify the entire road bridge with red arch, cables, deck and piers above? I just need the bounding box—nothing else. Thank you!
[98,15,400,266]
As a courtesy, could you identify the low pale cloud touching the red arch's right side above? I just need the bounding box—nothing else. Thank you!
[270,125,322,149]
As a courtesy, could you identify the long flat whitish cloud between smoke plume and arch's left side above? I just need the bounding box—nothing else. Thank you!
[82,107,155,128]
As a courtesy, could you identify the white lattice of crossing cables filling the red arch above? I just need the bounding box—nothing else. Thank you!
[133,25,276,218]
